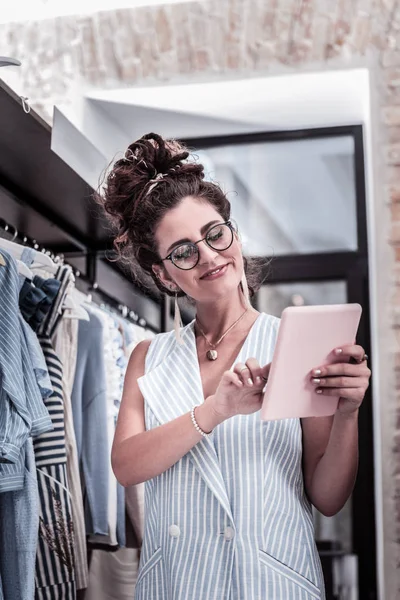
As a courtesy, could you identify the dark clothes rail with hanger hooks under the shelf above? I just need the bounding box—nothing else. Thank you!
[0,218,159,333]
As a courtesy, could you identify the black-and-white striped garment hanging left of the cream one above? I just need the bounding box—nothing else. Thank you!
[34,337,76,600]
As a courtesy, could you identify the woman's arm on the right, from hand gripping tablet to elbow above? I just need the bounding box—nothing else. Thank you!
[302,346,371,516]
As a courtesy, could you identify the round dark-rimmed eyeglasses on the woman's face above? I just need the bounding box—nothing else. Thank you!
[161,221,236,271]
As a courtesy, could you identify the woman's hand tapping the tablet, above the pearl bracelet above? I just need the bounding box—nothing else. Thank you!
[205,358,271,421]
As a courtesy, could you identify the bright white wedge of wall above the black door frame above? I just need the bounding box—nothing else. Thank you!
[87,68,369,132]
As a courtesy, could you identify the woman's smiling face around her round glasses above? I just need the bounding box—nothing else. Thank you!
[153,197,243,302]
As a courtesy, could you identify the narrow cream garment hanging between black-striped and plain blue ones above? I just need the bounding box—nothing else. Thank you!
[52,318,89,590]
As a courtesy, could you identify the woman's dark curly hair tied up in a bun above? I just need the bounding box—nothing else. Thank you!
[96,133,266,296]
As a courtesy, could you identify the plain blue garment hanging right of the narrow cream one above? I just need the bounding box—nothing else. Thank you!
[71,311,110,535]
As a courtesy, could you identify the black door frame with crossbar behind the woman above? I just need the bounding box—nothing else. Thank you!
[183,125,377,600]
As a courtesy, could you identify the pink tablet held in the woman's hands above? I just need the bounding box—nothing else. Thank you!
[261,304,362,421]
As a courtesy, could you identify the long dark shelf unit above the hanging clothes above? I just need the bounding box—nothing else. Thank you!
[0,79,168,331]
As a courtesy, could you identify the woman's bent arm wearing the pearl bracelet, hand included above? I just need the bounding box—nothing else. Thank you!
[111,341,269,486]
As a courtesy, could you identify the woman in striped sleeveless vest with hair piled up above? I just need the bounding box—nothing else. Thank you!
[99,134,370,600]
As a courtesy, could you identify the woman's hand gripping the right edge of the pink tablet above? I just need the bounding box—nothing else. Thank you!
[311,346,371,415]
